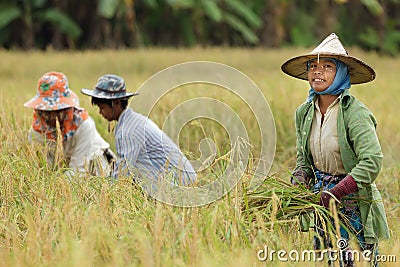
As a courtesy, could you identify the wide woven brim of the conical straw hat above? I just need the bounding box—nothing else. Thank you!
[281,53,376,84]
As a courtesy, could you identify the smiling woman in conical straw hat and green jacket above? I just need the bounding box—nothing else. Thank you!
[281,33,389,266]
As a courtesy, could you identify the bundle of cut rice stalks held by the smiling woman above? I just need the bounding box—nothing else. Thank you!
[242,176,372,253]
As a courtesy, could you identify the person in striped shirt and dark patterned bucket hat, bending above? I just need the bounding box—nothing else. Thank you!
[81,74,196,185]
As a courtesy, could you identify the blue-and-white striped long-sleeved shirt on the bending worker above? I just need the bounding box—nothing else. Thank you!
[113,108,196,185]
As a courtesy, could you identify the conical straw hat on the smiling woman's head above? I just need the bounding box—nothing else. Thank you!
[281,33,375,84]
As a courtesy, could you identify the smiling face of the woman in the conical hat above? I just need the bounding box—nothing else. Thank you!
[308,58,336,92]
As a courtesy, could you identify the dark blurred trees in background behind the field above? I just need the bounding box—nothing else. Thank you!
[0,0,400,55]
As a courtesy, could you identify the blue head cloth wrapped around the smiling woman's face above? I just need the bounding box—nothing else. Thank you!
[307,58,351,102]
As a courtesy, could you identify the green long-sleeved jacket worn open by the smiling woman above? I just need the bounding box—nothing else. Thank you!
[295,90,389,243]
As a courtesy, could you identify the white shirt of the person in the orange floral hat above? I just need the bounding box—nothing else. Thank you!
[28,117,110,175]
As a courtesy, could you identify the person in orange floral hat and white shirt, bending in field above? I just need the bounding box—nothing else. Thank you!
[24,71,115,176]
